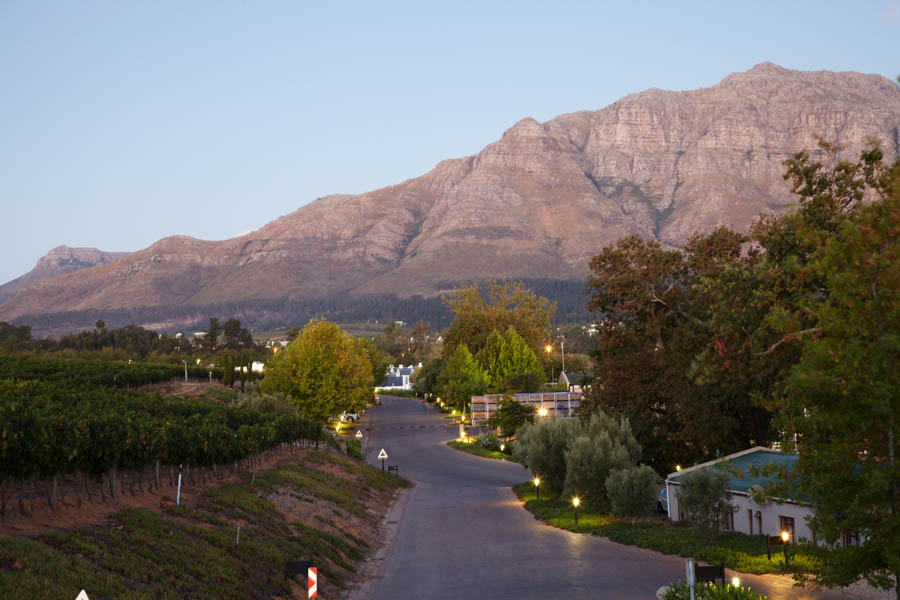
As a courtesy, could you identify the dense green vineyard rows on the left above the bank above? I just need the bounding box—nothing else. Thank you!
[0,357,322,514]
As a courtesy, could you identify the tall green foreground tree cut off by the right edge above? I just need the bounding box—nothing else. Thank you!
[782,163,900,598]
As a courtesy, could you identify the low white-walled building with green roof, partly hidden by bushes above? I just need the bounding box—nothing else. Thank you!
[666,446,828,544]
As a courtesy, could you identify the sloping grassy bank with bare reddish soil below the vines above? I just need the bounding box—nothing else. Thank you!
[0,452,408,600]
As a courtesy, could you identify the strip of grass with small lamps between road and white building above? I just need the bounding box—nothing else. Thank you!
[513,481,818,575]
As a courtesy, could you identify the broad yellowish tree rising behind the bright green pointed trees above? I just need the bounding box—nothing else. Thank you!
[443,280,556,354]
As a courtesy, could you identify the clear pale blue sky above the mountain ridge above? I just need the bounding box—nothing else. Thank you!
[0,0,900,283]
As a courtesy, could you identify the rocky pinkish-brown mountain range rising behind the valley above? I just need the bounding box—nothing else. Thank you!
[0,63,900,320]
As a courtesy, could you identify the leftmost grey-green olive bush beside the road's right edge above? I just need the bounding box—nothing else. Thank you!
[515,419,581,496]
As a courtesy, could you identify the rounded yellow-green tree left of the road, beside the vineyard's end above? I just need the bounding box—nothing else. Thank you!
[262,319,374,421]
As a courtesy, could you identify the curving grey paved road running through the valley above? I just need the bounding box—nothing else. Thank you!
[359,396,880,600]
